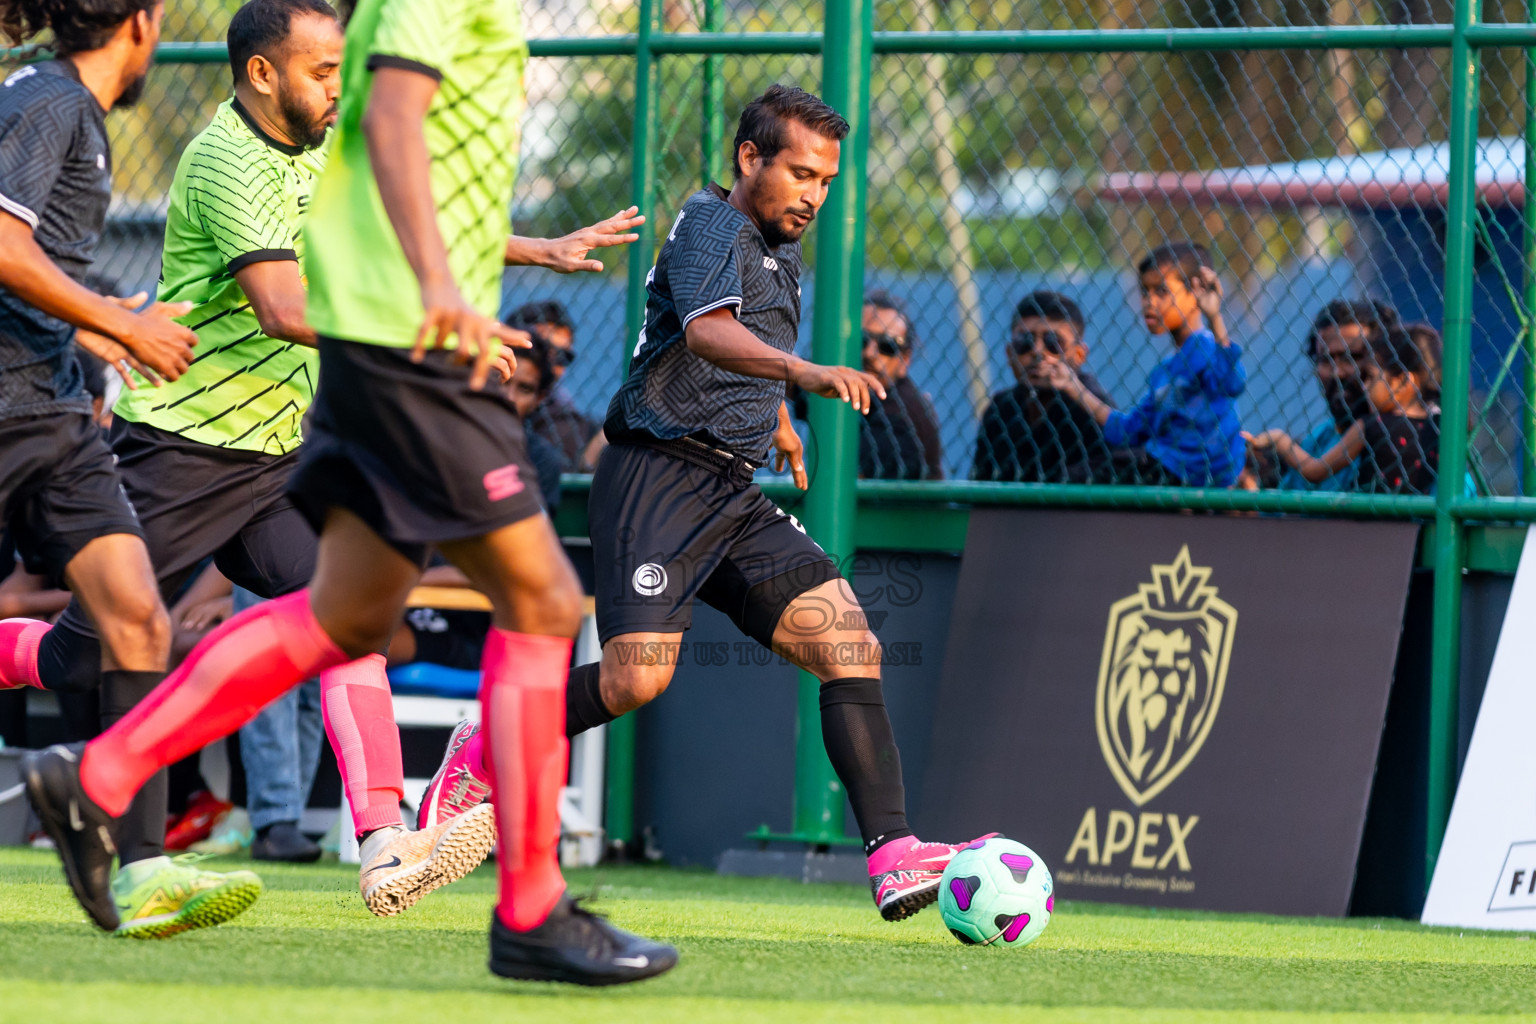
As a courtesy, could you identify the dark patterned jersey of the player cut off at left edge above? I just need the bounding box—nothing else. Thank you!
[0,60,112,418]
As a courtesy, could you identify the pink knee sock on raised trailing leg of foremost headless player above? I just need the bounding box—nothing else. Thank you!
[80,590,350,815]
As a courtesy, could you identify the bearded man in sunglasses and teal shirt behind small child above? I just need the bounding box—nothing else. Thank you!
[1279,299,1398,491]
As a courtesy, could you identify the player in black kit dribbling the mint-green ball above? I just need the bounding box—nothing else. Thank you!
[506,86,958,921]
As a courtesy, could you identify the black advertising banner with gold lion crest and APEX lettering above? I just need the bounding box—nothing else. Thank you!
[919,510,1418,915]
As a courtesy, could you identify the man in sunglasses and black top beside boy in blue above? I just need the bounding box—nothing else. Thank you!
[971,290,1115,484]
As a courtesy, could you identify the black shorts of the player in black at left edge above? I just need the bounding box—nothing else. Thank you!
[0,413,144,579]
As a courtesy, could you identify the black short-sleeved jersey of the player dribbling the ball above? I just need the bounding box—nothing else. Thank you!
[604,186,802,462]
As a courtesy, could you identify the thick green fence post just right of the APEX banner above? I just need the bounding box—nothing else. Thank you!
[1424,0,1482,883]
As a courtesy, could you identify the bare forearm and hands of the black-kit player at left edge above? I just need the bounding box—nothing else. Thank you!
[0,216,197,381]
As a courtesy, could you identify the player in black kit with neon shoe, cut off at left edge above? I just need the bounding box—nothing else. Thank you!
[0,0,261,936]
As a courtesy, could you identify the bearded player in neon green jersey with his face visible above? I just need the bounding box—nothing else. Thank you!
[16,0,642,936]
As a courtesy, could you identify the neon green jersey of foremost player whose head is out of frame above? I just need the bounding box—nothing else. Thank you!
[304,0,528,347]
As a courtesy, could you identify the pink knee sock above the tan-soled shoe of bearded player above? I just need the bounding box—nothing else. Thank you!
[319,654,406,835]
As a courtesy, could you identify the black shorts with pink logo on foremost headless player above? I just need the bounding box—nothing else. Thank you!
[289,338,542,565]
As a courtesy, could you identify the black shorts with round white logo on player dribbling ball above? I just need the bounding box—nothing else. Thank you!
[587,444,842,646]
